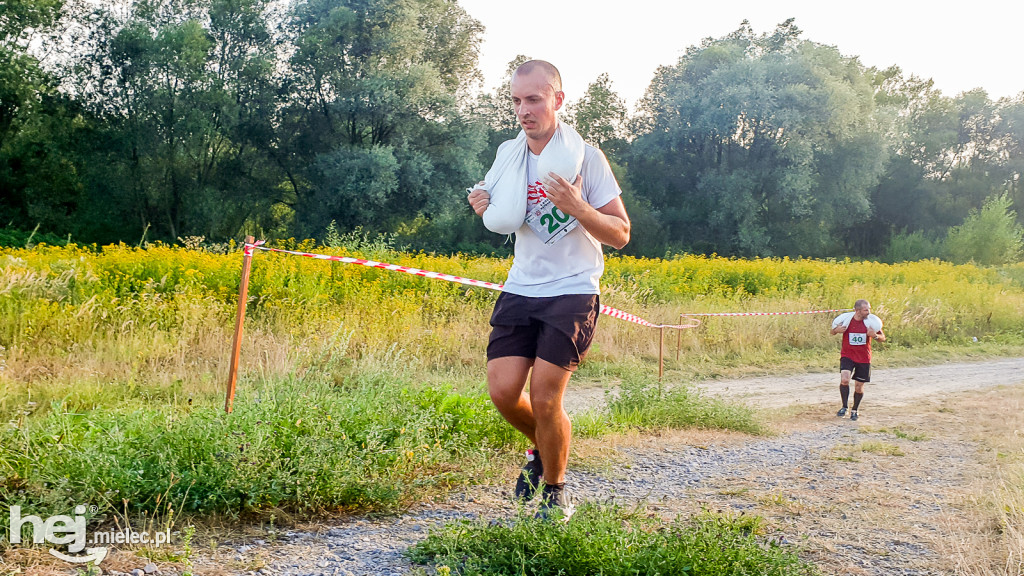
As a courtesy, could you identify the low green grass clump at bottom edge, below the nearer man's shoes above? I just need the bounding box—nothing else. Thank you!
[409,504,819,576]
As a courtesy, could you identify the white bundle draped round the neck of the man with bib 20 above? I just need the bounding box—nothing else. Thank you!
[476,121,586,234]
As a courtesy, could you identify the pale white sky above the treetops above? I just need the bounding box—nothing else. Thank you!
[459,0,1024,109]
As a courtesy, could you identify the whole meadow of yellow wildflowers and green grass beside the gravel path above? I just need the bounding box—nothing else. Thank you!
[0,243,1024,545]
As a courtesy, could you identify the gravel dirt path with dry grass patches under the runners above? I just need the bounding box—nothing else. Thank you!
[176,358,1024,576]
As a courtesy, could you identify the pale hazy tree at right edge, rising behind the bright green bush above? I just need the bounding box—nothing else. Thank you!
[864,74,1024,255]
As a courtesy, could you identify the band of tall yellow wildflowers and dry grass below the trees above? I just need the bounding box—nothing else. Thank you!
[0,242,1024,417]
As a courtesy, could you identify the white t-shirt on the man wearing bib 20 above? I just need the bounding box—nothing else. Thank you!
[505,145,623,297]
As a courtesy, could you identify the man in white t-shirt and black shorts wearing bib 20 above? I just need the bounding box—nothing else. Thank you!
[468,60,630,518]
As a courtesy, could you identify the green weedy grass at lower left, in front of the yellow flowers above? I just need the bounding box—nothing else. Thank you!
[0,366,522,535]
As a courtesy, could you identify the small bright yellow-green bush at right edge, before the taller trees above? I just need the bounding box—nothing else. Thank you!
[944,195,1024,265]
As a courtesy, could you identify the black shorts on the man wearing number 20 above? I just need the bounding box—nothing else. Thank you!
[487,292,601,370]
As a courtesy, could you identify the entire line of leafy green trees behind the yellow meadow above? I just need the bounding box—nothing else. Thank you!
[0,0,1024,263]
